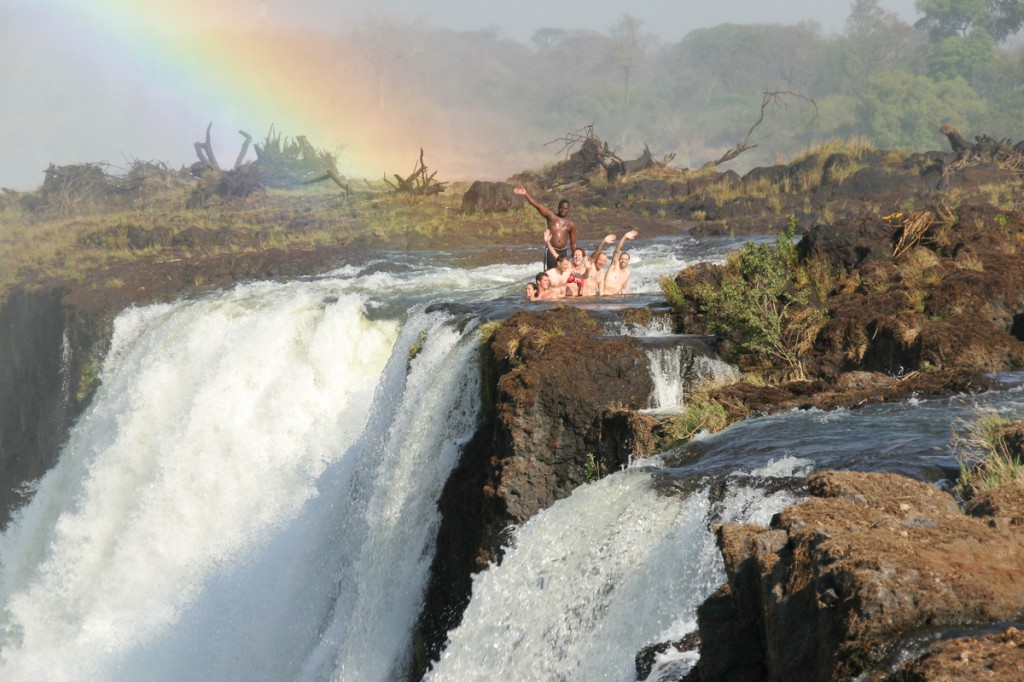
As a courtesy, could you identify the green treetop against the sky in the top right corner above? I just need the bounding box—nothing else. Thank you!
[914,0,1024,43]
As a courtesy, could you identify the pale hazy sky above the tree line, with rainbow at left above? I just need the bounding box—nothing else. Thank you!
[0,0,916,190]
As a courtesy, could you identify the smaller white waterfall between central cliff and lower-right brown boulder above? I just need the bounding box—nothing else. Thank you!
[426,456,806,682]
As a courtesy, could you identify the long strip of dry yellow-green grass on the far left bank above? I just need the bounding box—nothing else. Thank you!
[0,176,528,299]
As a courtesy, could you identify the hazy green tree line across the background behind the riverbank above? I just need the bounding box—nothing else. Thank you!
[299,0,1024,173]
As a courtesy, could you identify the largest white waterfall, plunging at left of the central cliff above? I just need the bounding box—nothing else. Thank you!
[0,282,479,680]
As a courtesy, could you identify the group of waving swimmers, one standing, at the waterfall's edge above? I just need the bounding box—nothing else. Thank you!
[513,187,637,301]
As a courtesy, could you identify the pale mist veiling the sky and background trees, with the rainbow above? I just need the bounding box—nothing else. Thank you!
[0,0,1019,189]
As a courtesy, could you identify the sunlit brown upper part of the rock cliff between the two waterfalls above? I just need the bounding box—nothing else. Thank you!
[486,307,653,530]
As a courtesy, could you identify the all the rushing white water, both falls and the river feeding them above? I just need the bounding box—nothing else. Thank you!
[0,239,1024,682]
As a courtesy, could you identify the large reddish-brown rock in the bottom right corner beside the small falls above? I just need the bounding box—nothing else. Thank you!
[688,472,1024,681]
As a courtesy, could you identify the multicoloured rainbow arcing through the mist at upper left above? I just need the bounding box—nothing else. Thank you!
[60,0,495,179]
